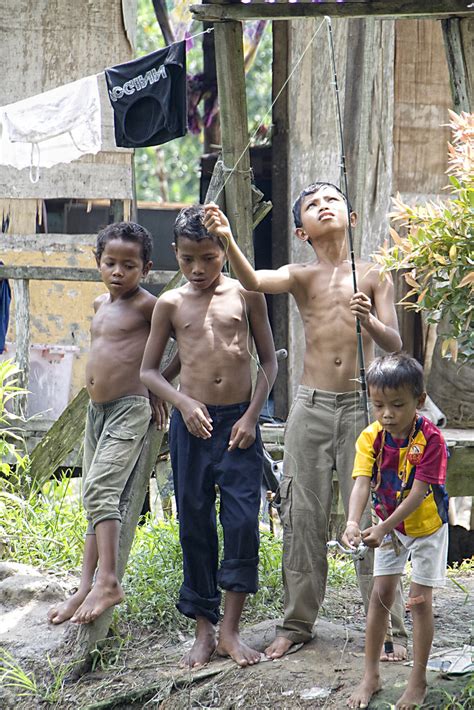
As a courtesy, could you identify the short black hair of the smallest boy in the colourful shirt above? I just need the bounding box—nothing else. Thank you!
[366,352,425,399]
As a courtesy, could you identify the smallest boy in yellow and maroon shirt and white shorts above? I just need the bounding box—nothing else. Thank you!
[343,353,448,710]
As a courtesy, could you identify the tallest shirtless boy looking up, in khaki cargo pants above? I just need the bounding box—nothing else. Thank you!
[205,182,406,658]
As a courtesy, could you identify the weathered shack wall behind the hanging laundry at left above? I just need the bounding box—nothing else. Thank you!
[0,0,136,418]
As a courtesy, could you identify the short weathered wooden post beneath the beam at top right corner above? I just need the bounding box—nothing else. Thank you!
[441,17,474,113]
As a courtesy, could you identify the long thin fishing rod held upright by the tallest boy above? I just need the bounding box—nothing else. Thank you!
[325,17,369,426]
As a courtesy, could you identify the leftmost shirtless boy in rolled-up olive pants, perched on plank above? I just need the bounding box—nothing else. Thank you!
[48,222,165,624]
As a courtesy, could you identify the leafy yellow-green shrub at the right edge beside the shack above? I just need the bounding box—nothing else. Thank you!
[374,111,474,362]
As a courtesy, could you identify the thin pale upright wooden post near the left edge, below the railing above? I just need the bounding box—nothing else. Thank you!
[13,279,30,417]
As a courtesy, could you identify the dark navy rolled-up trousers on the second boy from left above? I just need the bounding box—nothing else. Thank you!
[169,403,263,624]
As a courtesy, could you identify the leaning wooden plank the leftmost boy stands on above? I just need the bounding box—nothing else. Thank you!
[70,422,164,673]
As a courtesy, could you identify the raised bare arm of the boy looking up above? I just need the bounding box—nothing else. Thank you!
[204,202,292,294]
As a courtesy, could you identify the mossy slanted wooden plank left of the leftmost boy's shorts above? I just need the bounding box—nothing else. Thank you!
[30,387,89,486]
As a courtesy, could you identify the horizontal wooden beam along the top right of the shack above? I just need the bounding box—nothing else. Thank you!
[191,0,473,22]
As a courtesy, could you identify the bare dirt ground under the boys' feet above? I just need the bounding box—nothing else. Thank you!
[0,575,474,710]
